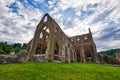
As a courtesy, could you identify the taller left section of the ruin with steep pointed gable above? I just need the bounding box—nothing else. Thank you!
[27,14,75,62]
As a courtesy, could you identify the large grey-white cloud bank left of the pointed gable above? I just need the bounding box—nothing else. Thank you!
[0,0,42,43]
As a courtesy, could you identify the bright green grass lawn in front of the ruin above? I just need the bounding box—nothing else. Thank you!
[0,62,120,80]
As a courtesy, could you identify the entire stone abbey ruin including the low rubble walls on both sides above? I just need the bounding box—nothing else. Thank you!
[0,14,120,65]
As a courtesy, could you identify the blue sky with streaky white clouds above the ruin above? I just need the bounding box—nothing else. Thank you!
[0,0,120,51]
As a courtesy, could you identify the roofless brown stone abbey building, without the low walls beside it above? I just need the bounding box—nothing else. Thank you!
[27,14,97,62]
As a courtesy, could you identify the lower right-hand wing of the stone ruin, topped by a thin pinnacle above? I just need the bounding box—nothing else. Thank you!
[70,29,97,62]
